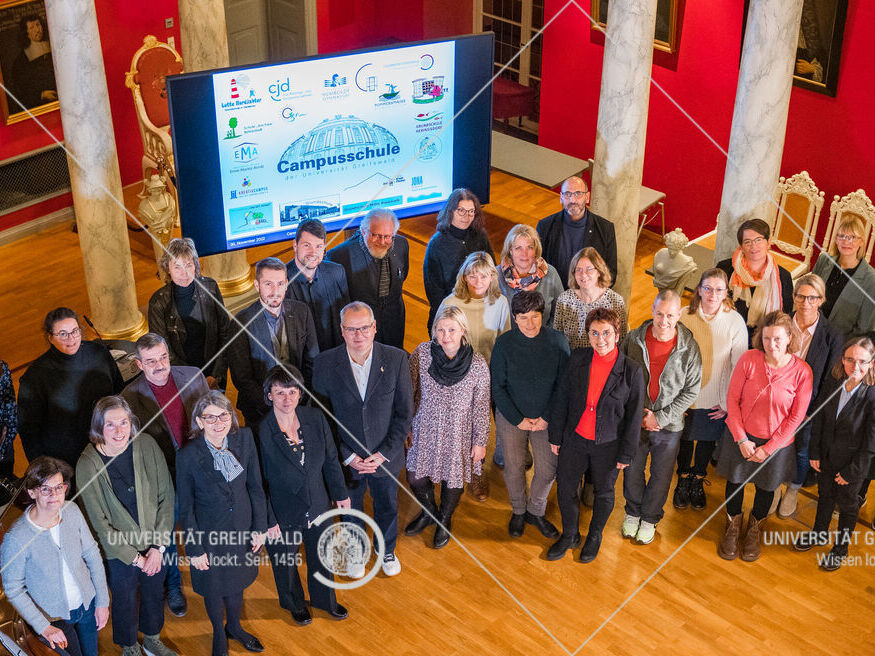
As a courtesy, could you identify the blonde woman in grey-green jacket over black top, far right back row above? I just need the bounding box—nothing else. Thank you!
[813,215,875,336]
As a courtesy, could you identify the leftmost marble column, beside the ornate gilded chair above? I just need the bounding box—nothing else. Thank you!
[46,0,146,340]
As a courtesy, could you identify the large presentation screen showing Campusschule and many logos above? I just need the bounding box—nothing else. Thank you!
[167,34,493,255]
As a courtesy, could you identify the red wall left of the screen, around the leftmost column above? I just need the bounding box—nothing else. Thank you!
[0,0,180,230]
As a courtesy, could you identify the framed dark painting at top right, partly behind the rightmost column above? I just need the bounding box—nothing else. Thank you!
[742,0,848,97]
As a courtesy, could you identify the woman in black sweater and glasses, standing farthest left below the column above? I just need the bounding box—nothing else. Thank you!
[18,307,124,467]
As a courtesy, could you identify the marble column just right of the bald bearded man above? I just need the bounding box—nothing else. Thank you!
[592,0,656,303]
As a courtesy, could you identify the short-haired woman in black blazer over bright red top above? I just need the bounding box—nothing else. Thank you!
[546,308,644,563]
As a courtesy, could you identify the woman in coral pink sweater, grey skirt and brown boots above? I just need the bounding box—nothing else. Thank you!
[717,311,812,561]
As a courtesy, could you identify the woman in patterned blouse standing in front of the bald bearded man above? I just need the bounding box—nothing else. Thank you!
[553,246,627,350]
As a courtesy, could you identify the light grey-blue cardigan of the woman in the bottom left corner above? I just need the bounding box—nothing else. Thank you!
[0,502,109,633]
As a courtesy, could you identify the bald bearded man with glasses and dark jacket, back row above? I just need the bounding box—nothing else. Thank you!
[536,175,617,289]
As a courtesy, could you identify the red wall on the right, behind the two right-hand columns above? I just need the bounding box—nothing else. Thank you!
[539,0,875,243]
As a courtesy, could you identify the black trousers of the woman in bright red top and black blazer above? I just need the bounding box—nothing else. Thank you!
[556,435,620,536]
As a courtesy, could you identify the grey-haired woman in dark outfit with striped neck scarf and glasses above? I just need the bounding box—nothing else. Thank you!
[176,391,267,656]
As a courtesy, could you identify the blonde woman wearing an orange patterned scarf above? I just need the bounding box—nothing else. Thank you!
[498,223,564,326]
